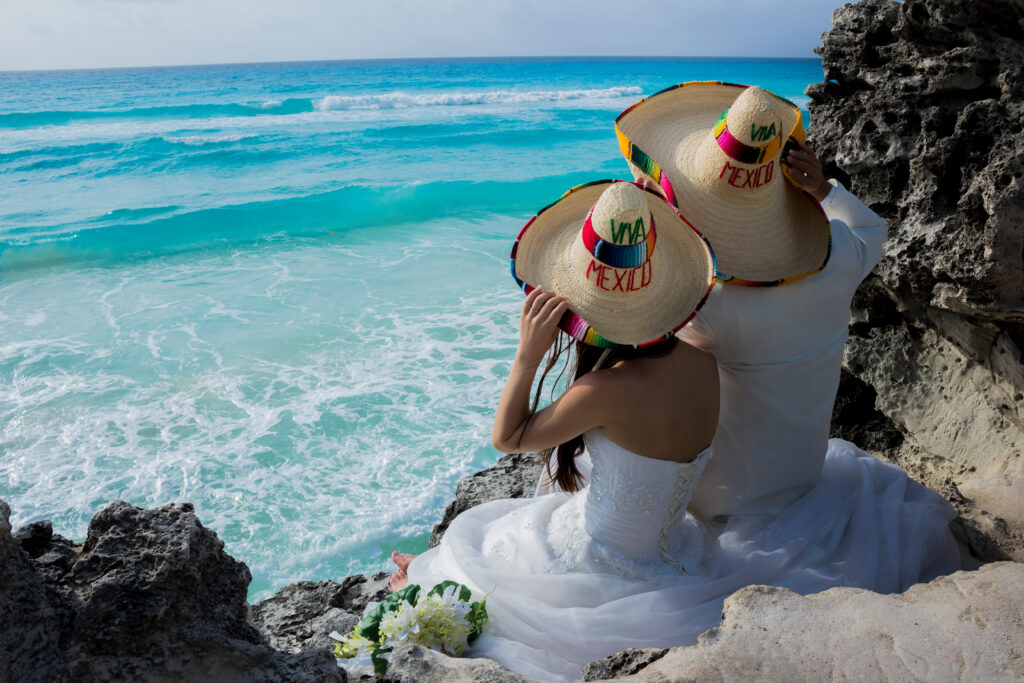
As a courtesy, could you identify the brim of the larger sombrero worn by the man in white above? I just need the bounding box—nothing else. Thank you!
[615,82,830,286]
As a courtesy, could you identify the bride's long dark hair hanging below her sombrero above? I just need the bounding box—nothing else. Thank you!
[520,332,678,494]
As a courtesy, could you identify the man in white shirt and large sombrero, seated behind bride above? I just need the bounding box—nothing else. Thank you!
[616,83,887,519]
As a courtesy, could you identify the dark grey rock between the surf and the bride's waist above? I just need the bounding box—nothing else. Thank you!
[430,453,543,548]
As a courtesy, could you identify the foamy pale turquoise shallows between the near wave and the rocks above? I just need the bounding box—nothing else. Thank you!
[0,224,521,599]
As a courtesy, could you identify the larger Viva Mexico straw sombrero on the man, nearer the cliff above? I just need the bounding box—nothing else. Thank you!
[615,81,831,286]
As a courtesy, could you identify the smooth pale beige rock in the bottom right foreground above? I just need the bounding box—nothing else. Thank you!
[598,562,1024,683]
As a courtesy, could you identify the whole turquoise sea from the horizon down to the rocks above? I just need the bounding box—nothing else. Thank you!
[0,58,822,600]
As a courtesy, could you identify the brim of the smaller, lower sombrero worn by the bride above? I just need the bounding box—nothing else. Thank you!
[512,180,715,346]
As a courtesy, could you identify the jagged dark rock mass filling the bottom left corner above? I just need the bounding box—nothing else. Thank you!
[0,501,344,682]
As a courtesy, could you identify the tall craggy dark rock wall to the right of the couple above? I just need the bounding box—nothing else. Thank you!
[807,0,1024,560]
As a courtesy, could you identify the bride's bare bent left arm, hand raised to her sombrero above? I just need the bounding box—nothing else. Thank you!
[490,289,606,453]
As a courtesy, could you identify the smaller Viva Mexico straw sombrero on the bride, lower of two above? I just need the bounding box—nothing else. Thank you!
[512,180,715,347]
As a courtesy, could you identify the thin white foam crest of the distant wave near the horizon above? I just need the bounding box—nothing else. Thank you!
[314,86,643,112]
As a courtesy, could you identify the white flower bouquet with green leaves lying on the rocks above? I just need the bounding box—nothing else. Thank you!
[331,581,487,676]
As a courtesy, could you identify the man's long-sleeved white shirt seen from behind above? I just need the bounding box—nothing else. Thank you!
[679,181,887,519]
